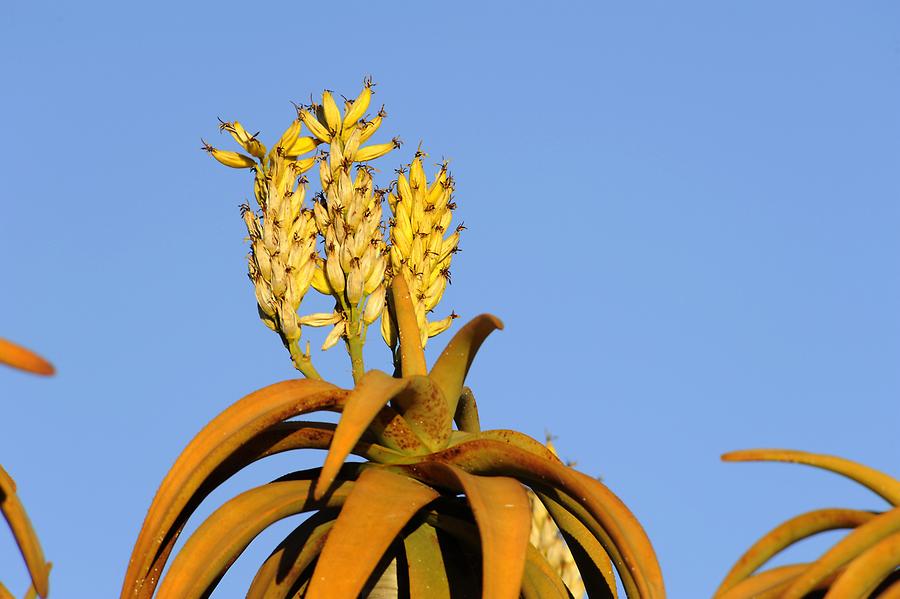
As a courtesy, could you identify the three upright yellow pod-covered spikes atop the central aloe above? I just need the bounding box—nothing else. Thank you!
[204,79,462,378]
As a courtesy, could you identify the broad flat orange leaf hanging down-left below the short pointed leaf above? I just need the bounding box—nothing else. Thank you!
[306,468,439,599]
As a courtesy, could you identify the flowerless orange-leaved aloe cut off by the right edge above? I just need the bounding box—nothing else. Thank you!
[714,449,900,599]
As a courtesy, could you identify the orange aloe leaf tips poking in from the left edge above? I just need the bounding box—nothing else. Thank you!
[0,339,54,599]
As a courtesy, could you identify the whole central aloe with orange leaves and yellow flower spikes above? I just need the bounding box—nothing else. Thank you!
[121,80,664,599]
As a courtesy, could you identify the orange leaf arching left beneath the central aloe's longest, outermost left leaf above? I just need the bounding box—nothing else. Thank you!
[157,480,353,599]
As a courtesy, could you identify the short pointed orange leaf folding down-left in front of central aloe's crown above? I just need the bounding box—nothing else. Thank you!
[315,372,408,499]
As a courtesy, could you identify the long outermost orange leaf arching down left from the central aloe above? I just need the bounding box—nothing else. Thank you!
[121,379,347,599]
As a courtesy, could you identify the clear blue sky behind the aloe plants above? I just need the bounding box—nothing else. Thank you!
[0,1,900,599]
